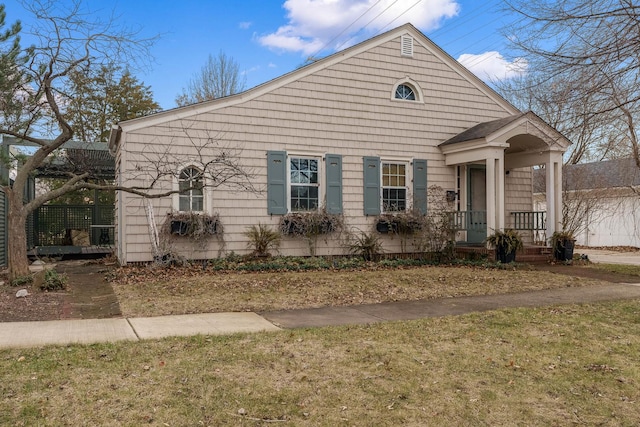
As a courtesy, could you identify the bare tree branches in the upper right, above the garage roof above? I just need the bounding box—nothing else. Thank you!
[505,0,640,166]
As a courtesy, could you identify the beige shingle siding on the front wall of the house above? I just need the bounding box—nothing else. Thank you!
[119,31,531,262]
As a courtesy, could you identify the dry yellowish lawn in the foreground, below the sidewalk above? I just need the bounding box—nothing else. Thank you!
[0,300,640,426]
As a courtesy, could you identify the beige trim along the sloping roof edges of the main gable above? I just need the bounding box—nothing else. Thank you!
[109,24,520,151]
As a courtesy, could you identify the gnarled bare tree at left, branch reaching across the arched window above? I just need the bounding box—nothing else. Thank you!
[0,4,255,279]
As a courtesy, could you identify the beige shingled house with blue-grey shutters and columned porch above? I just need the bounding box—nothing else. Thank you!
[109,24,570,263]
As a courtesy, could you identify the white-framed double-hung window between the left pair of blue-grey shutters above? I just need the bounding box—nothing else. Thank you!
[289,157,320,212]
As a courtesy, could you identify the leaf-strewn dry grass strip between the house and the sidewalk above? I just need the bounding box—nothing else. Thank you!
[112,266,599,317]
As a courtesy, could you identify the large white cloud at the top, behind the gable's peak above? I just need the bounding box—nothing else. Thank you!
[258,0,460,55]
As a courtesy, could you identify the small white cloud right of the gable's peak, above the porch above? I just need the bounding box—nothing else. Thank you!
[458,51,529,82]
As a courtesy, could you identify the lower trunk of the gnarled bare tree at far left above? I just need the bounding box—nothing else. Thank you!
[7,190,29,281]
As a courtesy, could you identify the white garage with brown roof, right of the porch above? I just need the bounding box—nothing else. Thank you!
[534,158,640,247]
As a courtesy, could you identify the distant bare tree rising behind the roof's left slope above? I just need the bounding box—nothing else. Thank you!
[176,51,246,107]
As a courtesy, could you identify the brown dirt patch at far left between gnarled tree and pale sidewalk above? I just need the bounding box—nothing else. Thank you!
[0,260,122,322]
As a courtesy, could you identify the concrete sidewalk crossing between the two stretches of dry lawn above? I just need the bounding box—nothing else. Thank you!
[0,283,640,349]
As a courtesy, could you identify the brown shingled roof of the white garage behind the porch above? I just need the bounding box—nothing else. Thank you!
[533,157,640,193]
